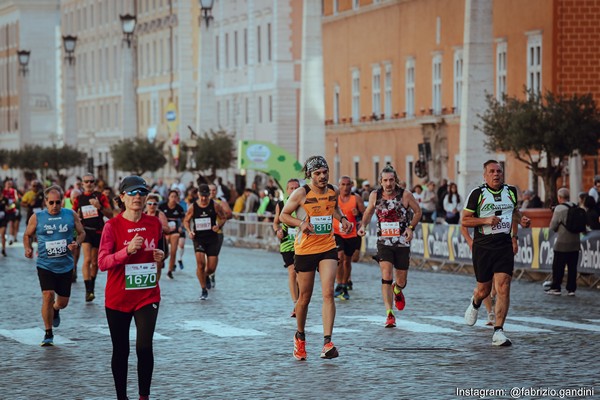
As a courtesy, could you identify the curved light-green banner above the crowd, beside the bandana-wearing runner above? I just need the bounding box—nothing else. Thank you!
[238,140,303,188]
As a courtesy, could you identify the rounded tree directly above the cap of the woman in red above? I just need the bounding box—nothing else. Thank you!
[110,138,167,176]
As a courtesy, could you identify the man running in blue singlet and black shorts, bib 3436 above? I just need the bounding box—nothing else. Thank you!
[23,186,85,346]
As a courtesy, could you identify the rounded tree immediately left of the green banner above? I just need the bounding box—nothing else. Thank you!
[186,130,235,181]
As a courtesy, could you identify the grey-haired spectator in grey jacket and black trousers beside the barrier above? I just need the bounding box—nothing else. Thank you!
[546,188,580,296]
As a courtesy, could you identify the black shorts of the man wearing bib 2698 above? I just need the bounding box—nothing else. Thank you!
[473,243,515,283]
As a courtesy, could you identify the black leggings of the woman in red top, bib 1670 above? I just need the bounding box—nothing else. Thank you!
[106,303,158,400]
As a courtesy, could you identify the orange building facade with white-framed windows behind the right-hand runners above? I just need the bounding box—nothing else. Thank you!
[323,0,600,195]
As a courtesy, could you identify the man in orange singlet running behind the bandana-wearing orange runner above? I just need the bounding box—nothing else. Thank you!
[333,176,365,300]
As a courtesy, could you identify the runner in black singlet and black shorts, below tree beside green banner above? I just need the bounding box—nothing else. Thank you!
[183,183,227,300]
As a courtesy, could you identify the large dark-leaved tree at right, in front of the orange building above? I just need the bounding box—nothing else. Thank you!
[476,91,600,206]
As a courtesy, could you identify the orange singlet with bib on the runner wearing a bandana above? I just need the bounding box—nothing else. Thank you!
[294,184,336,255]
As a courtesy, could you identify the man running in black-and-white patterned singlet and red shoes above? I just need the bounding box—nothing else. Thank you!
[358,165,421,328]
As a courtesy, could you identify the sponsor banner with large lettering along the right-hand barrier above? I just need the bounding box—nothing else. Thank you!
[366,223,600,273]
